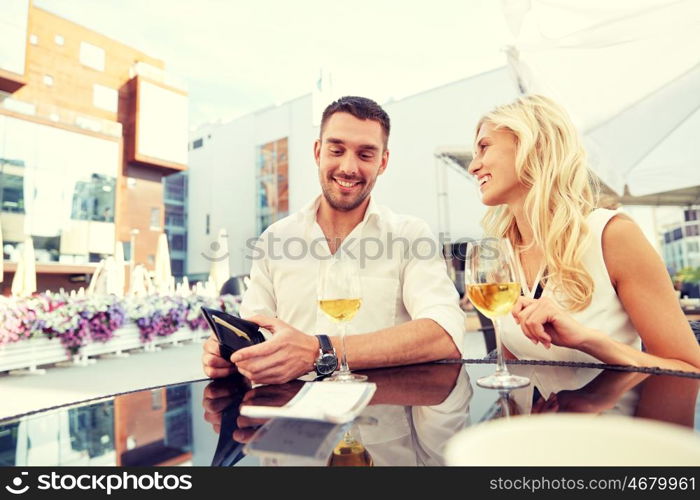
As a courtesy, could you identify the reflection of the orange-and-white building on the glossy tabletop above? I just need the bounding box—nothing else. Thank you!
[0,385,192,466]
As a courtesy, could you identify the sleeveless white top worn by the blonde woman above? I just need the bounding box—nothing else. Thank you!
[501,208,642,363]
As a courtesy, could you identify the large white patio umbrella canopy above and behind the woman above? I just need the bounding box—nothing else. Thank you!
[503,0,700,204]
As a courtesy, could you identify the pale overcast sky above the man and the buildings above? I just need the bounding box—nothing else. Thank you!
[34,0,511,129]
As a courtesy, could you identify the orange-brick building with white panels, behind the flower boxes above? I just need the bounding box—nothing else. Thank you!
[0,0,188,293]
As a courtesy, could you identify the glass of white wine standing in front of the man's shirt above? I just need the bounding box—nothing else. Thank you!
[318,258,367,382]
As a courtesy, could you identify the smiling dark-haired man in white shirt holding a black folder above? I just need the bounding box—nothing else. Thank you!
[202,97,464,384]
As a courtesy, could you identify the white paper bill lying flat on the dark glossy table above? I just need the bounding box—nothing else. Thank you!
[241,382,377,424]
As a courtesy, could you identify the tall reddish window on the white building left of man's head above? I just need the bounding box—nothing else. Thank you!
[255,137,289,234]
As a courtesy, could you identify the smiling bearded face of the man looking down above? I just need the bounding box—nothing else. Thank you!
[314,112,389,211]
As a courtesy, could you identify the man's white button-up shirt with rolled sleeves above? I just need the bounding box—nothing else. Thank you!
[240,193,464,352]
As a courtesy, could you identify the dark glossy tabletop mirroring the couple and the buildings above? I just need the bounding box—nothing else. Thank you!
[0,363,700,466]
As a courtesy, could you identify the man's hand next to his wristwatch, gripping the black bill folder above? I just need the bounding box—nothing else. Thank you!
[231,315,319,384]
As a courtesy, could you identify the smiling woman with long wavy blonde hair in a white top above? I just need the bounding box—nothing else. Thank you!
[469,95,700,372]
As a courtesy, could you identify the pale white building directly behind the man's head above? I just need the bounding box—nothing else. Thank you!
[187,67,517,276]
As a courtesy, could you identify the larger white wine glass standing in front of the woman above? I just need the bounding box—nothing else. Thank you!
[464,238,530,389]
